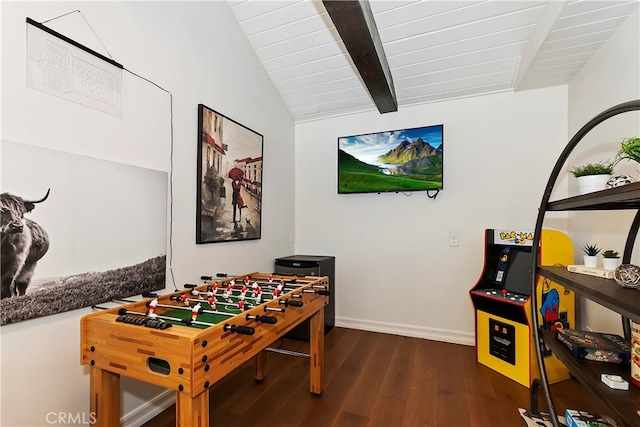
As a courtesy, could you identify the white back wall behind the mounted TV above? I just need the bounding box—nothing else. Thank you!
[295,87,567,344]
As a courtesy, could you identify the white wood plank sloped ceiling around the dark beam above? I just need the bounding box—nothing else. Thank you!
[229,0,640,121]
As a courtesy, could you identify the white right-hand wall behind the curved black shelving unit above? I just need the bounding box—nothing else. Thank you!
[567,10,640,333]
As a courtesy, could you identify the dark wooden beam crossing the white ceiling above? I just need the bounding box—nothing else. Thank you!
[322,0,398,114]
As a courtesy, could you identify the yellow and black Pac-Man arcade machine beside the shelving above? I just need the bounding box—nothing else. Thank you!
[469,229,575,388]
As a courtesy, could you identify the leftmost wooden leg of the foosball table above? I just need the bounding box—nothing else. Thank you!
[89,366,120,427]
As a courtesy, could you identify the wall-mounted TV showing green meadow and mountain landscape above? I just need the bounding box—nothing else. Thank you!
[338,125,444,194]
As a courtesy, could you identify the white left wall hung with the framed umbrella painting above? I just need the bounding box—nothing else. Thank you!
[0,2,295,426]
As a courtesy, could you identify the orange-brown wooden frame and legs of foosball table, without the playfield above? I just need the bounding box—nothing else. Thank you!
[80,273,329,427]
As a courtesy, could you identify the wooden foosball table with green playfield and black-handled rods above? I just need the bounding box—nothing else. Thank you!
[80,273,329,426]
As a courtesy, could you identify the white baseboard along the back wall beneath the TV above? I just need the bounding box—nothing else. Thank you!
[336,317,476,346]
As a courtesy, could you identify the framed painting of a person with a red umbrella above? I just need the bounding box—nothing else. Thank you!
[196,104,263,243]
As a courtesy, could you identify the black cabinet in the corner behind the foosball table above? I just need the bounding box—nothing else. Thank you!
[275,255,336,340]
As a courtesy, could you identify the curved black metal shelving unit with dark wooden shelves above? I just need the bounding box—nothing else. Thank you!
[531,100,640,427]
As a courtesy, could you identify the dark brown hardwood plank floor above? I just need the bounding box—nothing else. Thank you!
[144,327,602,427]
